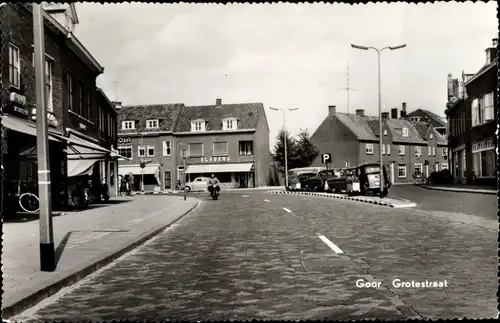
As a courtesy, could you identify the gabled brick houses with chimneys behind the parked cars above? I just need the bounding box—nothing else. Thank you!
[311,103,445,183]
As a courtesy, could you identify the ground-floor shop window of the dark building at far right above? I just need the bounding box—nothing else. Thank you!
[472,138,497,185]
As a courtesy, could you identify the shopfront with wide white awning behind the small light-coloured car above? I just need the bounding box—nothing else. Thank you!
[186,163,255,188]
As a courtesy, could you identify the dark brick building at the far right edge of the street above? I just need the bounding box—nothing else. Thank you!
[446,38,498,186]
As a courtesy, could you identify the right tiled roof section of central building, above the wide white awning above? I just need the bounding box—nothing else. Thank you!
[175,103,265,132]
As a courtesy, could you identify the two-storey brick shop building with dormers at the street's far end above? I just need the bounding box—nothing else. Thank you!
[115,99,269,191]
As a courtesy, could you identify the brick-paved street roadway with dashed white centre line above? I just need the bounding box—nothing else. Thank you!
[12,192,498,322]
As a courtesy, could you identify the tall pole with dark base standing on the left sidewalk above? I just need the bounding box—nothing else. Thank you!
[32,3,56,272]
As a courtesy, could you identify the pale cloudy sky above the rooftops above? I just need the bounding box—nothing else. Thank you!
[75,1,498,145]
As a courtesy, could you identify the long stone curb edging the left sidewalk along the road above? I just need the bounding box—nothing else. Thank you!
[2,200,200,319]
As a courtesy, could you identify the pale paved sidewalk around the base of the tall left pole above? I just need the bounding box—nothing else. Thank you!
[2,196,199,318]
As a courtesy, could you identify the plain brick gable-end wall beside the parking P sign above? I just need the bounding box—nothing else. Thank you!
[311,116,358,168]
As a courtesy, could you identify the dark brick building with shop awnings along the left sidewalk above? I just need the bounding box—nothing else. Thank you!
[0,4,116,211]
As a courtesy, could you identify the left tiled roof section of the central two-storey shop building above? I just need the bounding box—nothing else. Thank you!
[117,103,184,133]
